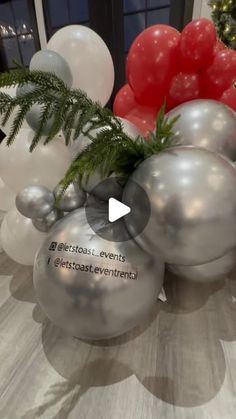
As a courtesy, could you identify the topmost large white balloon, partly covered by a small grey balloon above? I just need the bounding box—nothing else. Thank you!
[48,25,114,105]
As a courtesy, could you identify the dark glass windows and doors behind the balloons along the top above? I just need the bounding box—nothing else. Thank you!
[0,0,193,93]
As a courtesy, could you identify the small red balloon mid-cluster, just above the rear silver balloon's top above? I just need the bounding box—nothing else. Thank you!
[167,73,200,109]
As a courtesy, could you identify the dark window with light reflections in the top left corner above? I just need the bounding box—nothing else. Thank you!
[0,0,39,69]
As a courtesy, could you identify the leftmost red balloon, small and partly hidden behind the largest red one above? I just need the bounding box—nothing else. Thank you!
[113,84,137,118]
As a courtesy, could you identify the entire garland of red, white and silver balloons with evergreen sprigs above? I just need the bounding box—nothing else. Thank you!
[0,19,236,339]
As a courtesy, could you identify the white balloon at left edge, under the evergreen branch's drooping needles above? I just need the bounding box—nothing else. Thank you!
[0,128,70,192]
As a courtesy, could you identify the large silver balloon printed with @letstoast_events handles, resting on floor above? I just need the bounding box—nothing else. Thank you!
[34,208,164,339]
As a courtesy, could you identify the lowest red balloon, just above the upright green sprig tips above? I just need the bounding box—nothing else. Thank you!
[125,105,159,137]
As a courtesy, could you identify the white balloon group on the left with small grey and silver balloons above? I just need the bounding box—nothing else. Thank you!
[0,25,114,264]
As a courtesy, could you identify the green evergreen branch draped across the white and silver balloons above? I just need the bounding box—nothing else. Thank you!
[0,68,178,190]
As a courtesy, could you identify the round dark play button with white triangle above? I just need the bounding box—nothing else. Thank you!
[85,176,151,242]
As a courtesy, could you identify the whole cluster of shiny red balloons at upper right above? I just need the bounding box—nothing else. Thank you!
[113,18,236,136]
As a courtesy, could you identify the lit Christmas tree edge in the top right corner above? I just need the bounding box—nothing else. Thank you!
[209,0,236,50]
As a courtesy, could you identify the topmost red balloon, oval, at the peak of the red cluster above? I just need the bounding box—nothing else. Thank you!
[180,18,217,72]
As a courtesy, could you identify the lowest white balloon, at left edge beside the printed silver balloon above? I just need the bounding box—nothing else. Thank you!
[1,206,46,265]
